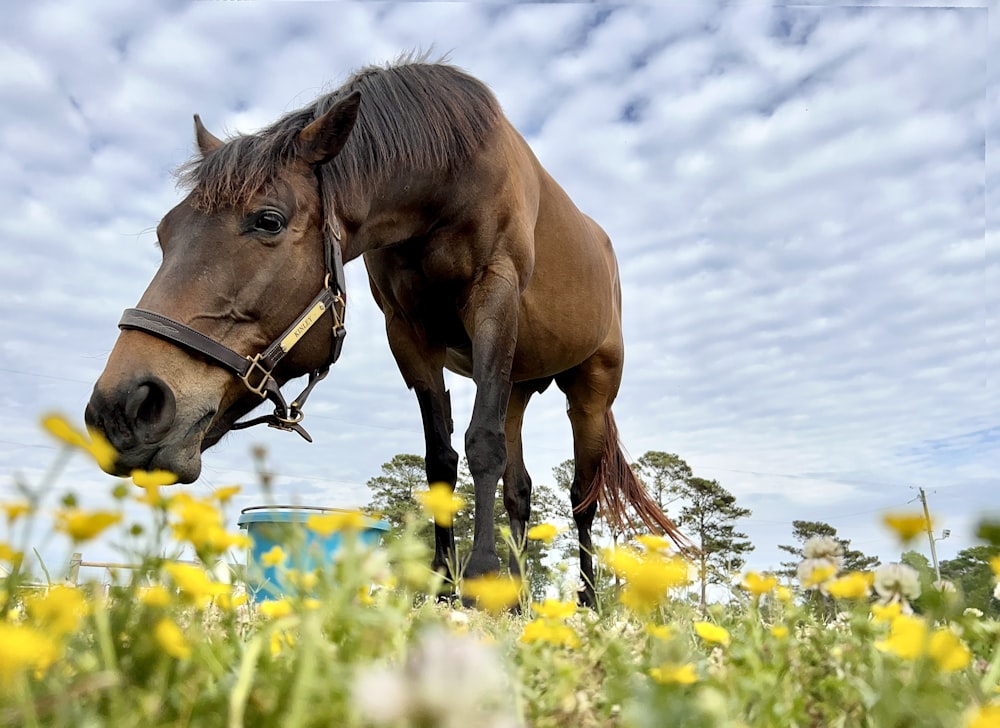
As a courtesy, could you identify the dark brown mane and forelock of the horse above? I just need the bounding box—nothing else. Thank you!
[177,58,501,210]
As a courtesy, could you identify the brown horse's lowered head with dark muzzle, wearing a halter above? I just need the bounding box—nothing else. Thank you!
[85,93,359,482]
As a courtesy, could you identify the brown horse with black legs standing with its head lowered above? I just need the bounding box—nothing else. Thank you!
[86,62,684,604]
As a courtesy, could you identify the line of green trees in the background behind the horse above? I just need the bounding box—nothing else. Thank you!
[366,450,1000,616]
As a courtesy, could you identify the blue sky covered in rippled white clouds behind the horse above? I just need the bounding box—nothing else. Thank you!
[0,0,1000,580]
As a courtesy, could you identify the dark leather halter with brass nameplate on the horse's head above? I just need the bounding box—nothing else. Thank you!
[118,182,347,442]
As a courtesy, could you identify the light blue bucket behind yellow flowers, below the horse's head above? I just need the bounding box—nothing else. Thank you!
[237,506,389,603]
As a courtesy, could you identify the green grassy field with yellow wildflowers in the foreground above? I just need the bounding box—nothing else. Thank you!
[0,419,1000,728]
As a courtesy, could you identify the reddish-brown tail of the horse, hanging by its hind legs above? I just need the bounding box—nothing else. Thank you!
[576,409,694,552]
